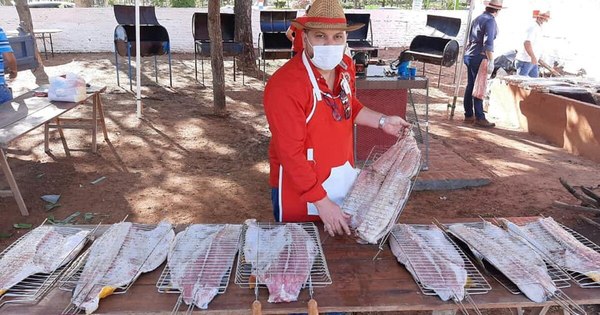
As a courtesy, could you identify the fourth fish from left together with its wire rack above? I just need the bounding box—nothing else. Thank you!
[235,220,331,303]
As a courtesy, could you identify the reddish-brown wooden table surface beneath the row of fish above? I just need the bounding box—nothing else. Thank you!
[0,219,600,314]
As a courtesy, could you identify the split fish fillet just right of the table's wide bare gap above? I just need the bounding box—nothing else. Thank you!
[390,224,467,301]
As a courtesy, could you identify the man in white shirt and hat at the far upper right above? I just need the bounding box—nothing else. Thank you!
[516,11,550,78]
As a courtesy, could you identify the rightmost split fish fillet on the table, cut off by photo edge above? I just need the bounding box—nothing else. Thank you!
[504,218,600,283]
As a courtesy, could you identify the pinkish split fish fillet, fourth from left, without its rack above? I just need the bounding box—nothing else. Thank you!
[244,223,317,303]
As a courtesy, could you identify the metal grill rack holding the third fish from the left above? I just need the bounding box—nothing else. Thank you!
[156,224,242,314]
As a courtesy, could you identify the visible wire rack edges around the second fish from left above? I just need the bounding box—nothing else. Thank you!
[59,223,172,314]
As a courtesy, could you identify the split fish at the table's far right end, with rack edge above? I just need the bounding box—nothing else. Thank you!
[501,218,600,288]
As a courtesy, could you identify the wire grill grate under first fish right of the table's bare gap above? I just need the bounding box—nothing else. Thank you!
[392,224,492,295]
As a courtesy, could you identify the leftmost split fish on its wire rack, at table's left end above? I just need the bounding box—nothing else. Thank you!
[0,225,90,305]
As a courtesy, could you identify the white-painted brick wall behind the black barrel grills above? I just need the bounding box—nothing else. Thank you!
[0,6,467,52]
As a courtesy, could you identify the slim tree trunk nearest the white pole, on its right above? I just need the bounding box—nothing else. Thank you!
[208,0,226,116]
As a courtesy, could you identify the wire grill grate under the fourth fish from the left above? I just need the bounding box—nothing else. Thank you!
[235,222,332,288]
